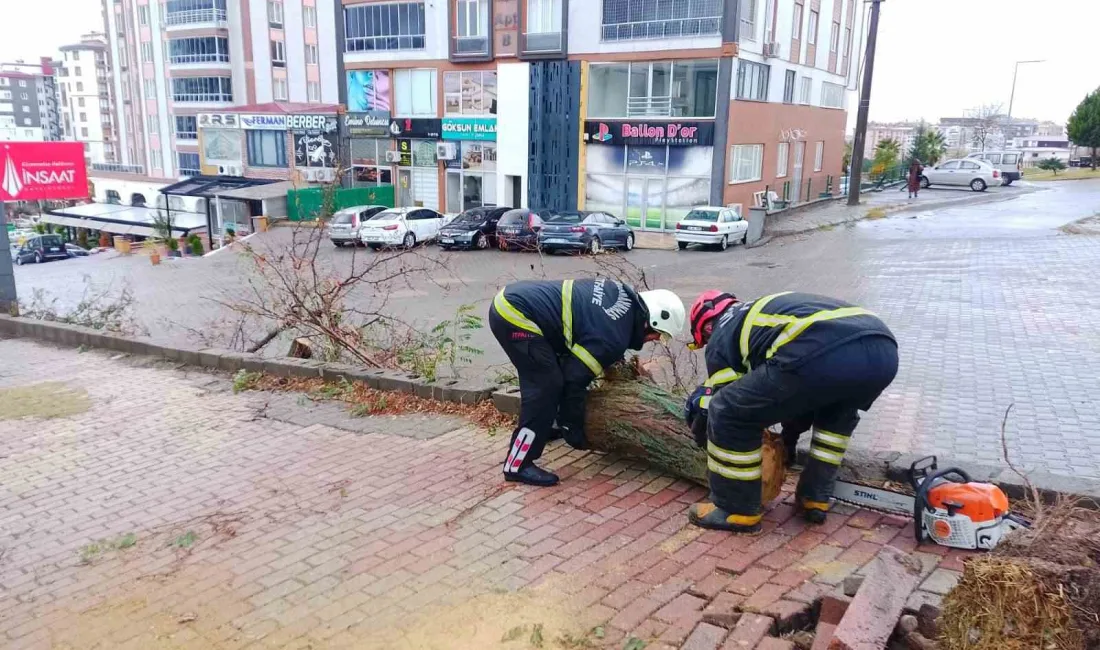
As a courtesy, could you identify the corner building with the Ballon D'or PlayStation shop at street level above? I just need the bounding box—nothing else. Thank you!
[337,0,862,229]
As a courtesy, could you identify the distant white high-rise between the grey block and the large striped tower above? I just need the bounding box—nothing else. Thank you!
[57,32,119,165]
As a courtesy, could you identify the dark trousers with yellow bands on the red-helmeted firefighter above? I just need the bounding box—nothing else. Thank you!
[707,335,898,521]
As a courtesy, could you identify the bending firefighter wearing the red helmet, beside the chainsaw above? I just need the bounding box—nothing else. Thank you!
[685,290,898,532]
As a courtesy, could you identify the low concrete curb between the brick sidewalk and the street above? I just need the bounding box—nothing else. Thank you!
[8,315,1100,509]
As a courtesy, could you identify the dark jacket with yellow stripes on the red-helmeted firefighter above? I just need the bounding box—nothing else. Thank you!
[706,291,894,387]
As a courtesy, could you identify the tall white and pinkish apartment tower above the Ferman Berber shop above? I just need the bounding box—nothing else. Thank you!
[103,0,339,179]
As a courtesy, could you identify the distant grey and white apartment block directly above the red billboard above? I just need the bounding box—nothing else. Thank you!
[0,58,61,140]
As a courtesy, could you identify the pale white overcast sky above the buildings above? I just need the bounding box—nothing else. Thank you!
[0,0,1100,125]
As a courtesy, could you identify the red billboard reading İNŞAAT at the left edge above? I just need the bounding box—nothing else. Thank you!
[0,142,88,201]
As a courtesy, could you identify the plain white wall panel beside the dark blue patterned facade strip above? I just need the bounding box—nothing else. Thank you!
[496,63,531,208]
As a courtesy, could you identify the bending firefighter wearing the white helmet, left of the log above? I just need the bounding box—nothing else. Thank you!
[488,278,686,485]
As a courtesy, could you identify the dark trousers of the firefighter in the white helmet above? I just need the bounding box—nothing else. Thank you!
[488,309,585,473]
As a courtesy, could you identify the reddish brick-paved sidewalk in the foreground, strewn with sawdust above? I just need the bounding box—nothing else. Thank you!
[0,340,966,650]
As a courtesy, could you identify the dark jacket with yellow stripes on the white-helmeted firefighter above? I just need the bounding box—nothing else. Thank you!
[493,277,649,387]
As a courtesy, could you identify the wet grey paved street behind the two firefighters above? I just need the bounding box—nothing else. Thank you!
[17,180,1100,480]
